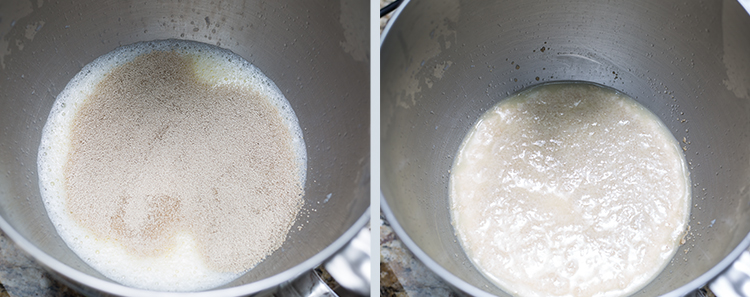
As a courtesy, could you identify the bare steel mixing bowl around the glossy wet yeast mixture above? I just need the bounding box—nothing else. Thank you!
[380,0,750,296]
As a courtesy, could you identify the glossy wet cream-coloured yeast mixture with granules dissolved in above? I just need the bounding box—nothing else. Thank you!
[450,83,690,296]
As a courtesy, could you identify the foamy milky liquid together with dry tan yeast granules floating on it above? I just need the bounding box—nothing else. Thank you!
[38,40,306,291]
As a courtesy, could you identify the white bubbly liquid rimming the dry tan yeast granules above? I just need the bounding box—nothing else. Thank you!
[38,40,306,291]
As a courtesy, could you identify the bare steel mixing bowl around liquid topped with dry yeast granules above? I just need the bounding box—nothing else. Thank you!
[0,1,370,296]
